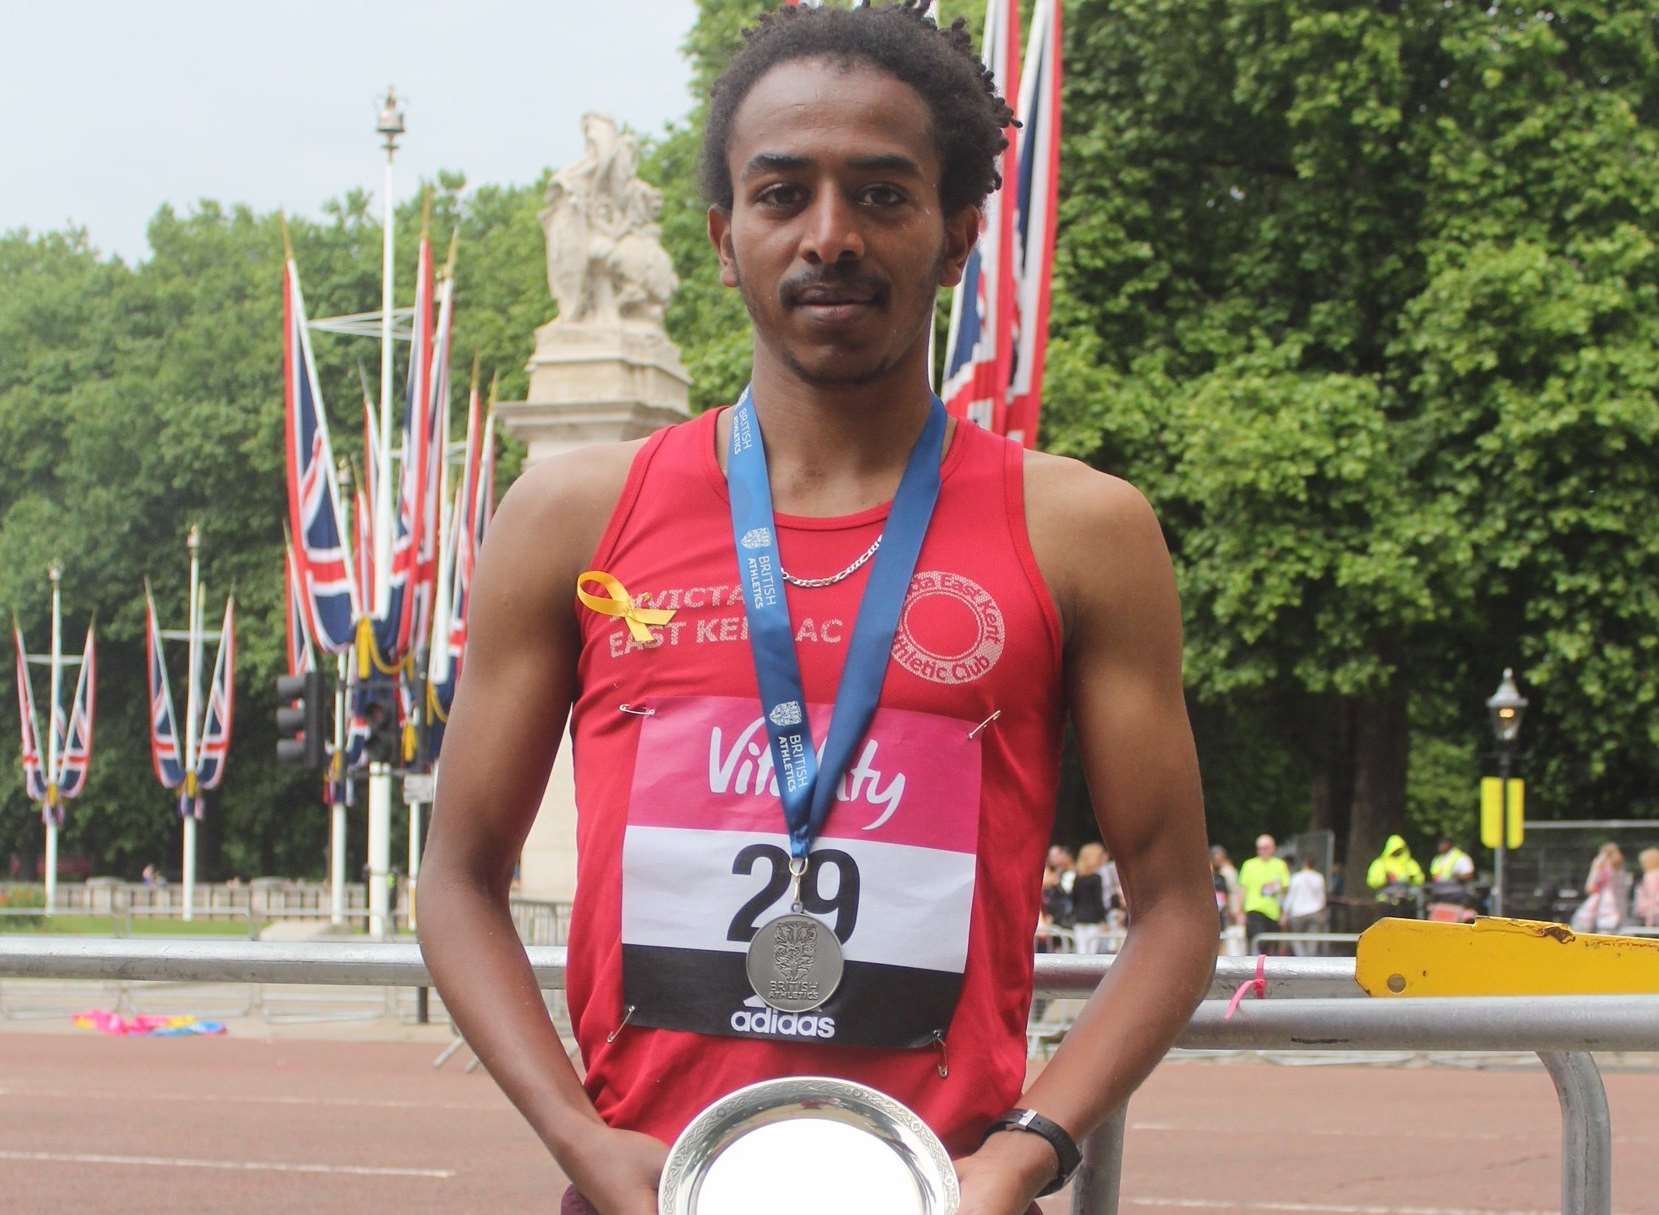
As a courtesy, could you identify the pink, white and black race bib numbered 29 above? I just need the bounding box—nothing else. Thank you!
[622,697,980,1047]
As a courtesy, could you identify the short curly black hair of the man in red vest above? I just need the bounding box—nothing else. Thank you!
[700,0,1017,216]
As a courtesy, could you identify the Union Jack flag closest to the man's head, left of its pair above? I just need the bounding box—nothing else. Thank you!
[939,0,1020,435]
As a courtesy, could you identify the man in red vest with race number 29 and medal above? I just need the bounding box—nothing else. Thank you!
[420,5,1214,1215]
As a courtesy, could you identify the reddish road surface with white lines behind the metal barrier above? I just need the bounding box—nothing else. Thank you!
[0,1026,1659,1215]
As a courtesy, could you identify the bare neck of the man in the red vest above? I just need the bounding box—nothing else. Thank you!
[720,341,932,516]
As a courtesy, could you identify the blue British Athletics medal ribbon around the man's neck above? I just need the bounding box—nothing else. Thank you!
[727,388,946,861]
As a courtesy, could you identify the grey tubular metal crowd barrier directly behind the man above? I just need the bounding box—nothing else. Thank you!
[0,938,1659,1215]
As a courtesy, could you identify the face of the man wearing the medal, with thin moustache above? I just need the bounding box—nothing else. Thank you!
[708,60,979,385]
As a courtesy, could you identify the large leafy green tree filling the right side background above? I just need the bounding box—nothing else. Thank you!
[1045,0,1659,863]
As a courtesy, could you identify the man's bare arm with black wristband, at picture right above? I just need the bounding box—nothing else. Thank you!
[962,456,1216,1208]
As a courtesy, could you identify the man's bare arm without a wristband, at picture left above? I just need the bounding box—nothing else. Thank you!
[420,446,660,1215]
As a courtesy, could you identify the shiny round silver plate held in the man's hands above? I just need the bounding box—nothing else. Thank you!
[657,1076,962,1215]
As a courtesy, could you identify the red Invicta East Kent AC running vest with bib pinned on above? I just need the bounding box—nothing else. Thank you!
[567,410,1062,1154]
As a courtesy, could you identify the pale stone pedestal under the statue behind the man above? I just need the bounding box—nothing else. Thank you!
[496,320,690,901]
